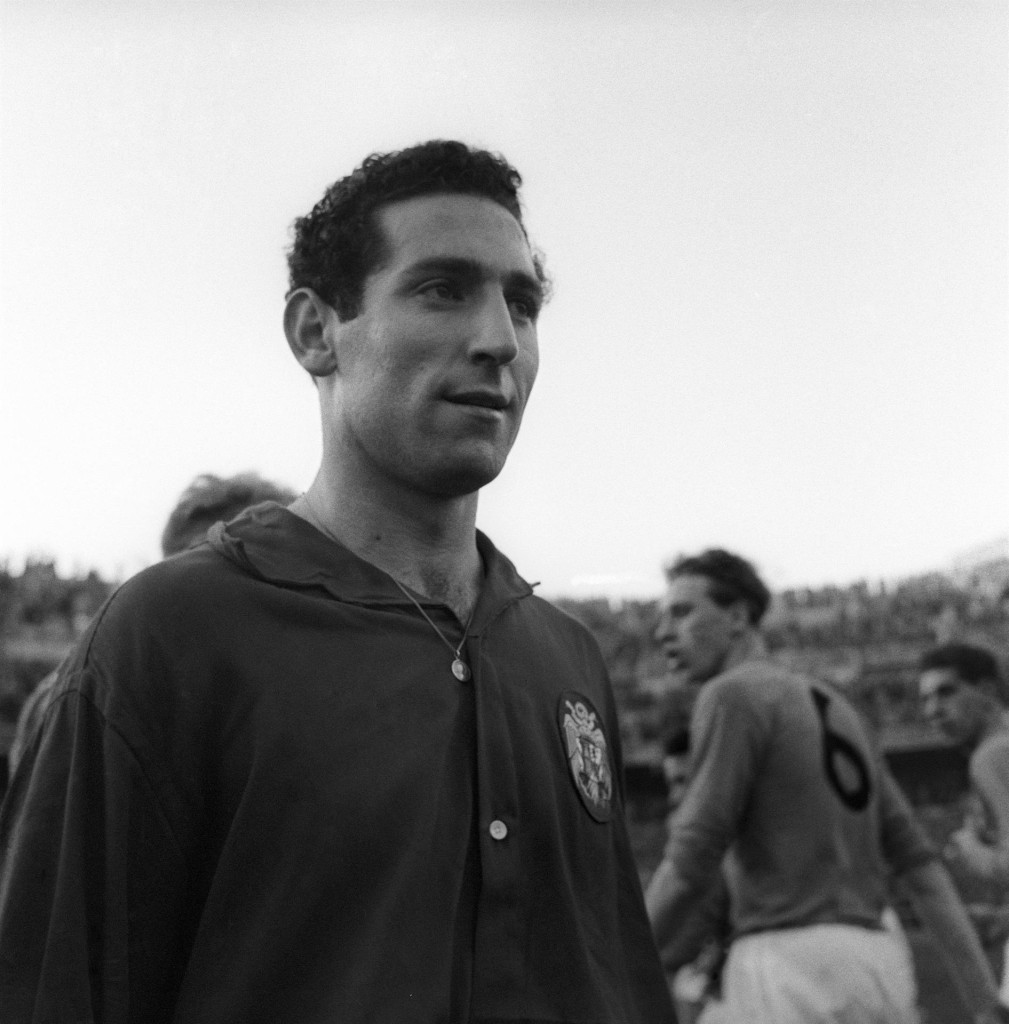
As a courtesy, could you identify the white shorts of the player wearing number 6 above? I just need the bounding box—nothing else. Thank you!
[722,925,919,1024]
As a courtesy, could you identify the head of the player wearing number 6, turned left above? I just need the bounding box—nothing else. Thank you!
[656,548,770,683]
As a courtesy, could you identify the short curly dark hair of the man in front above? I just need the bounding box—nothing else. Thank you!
[287,139,546,321]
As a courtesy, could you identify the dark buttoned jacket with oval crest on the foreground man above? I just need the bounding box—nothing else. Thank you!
[0,504,673,1024]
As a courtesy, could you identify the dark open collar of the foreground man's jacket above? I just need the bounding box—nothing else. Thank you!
[207,502,533,633]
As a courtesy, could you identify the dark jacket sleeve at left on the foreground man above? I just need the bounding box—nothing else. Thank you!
[0,687,185,1024]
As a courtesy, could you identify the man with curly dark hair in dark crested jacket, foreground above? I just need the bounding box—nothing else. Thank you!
[0,141,673,1024]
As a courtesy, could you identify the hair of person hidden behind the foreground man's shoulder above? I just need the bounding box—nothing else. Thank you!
[161,473,297,558]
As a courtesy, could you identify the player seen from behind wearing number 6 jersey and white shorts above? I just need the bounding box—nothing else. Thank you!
[646,549,1002,1024]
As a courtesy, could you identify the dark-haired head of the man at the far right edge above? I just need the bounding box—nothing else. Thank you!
[918,643,1005,743]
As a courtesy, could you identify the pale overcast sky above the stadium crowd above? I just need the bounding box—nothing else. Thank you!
[0,0,1009,597]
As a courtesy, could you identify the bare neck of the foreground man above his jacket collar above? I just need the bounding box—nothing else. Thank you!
[291,477,482,623]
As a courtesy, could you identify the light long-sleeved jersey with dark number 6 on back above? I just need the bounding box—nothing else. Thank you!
[666,659,935,936]
